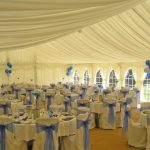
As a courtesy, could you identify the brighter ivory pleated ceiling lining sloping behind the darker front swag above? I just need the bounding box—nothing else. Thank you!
[16,0,150,63]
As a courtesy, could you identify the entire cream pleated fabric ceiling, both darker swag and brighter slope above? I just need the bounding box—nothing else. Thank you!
[0,0,150,63]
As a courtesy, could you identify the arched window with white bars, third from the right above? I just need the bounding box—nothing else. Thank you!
[109,70,118,87]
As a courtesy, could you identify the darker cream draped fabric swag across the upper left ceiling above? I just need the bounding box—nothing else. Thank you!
[0,0,144,51]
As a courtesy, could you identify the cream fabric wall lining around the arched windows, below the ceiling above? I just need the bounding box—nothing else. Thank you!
[0,62,145,89]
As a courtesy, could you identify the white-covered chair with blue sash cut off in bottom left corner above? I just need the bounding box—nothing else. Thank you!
[0,116,27,150]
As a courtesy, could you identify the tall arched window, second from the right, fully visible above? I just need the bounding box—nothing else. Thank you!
[125,69,135,88]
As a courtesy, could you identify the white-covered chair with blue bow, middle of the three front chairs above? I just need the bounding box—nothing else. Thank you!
[33,118,59,150]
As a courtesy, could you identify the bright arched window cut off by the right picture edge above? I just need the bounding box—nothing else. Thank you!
[143,75,150,101]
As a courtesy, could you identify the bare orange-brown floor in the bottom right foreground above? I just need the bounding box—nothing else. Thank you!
[90,109,145,150]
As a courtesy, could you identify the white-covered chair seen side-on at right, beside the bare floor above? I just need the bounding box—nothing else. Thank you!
[127,107,147,148]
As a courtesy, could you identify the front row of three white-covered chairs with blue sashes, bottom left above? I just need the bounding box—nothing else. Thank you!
[0,113,90,150]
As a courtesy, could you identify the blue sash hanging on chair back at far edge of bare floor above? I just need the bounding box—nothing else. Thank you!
[104,103,116,124]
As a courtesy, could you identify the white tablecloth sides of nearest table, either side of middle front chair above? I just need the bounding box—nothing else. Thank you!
[14,118,77,141]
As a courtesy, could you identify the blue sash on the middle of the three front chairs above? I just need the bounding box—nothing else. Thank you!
[37,125,58,150]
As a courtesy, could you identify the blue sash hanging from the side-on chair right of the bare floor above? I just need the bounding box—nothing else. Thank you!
[122,110,131,132]
